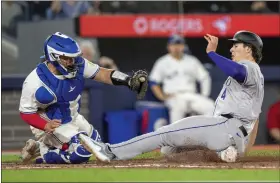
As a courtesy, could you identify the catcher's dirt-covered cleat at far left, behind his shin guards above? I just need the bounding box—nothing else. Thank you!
[21,139,40,163]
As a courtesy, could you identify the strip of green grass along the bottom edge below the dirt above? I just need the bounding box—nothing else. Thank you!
[2,168,279,182]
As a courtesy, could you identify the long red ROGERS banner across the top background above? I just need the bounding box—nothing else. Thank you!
[77,14,280,38]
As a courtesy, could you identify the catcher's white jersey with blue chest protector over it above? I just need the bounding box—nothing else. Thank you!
[19,57,99,124]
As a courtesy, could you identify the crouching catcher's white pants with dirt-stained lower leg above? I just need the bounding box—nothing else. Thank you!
[30,114,94,149]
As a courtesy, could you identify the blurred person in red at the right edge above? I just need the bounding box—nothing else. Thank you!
[267,100,280,143]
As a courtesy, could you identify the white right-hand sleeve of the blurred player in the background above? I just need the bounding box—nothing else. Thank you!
[193,57,211,96]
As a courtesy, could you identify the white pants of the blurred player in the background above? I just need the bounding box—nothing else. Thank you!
[165,93,215,123]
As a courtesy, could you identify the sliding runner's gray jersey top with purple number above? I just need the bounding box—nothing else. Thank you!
[213,61,264,133]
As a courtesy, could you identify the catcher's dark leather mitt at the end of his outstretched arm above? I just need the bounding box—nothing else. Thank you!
[129,70,148,100]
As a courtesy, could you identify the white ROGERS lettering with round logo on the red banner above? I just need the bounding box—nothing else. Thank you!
[133,16,203,35]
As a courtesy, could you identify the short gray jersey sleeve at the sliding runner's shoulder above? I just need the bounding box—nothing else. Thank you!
[241,63,261,86]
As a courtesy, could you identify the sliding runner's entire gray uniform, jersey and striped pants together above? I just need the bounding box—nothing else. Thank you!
[106,61,264,159]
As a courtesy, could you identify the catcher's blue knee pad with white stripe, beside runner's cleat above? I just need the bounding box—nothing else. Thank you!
[69,145,92,164]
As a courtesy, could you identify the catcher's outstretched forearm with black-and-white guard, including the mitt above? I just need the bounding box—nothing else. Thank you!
[93,67,148,99]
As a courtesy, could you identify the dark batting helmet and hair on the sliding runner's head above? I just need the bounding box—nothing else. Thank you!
[229,30,263,63]
